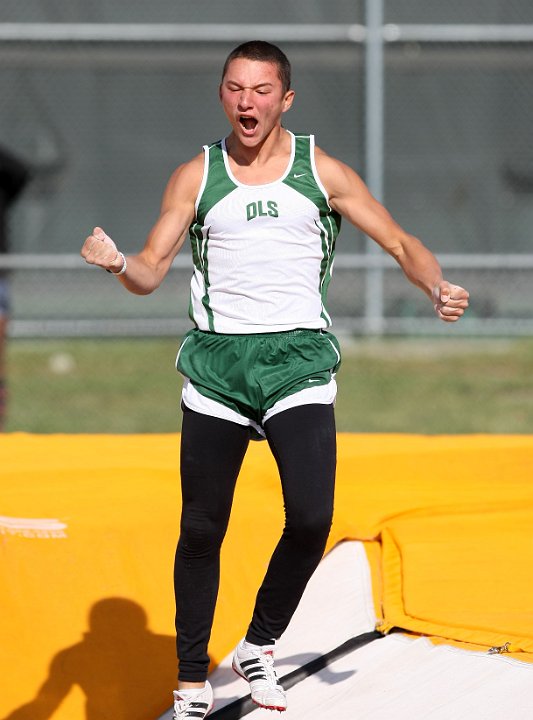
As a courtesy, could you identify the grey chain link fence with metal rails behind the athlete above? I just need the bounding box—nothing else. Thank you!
[0,0,533,434]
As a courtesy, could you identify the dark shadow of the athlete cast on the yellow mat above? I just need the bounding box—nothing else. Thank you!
[2,597,176,720]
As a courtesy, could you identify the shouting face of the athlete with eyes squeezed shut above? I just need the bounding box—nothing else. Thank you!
[220,58,294,147]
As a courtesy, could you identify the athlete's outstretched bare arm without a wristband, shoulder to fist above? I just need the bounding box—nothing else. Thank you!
[315,149,468,322]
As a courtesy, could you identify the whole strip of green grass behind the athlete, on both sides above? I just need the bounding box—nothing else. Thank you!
[7,338,533,434]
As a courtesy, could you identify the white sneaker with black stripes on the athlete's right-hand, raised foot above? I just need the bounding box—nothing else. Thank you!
[232,640,287,712]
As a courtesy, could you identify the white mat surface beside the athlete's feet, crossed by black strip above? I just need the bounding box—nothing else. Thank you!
[161,542,533,720]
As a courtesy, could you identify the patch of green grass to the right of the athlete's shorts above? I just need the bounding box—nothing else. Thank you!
[337,339,533,434]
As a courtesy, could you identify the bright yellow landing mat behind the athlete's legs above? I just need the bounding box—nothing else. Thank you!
[0,434,533,720]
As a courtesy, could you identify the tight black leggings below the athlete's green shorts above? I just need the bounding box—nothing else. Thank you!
[174,405,336,682]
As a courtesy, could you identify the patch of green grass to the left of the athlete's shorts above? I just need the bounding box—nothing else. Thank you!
[6,339,181,433]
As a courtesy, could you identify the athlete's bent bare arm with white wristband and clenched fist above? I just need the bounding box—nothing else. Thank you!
[81,155,203,295]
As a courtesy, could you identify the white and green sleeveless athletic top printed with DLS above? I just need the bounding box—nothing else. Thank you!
[185,133,340,334]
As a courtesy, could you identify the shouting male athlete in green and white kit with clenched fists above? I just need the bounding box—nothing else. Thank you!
[82,41,468,720]
